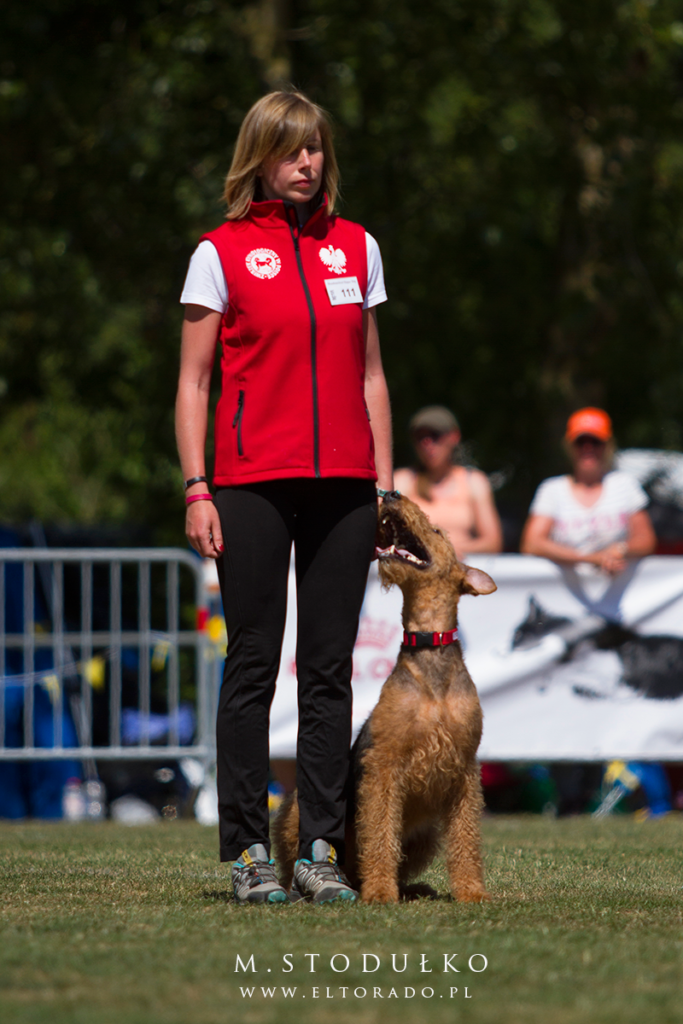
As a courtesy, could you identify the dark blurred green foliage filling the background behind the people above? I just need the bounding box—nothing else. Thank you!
[0,0,683,543]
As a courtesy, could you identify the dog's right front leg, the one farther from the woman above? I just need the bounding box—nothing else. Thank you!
[445,764,489,903]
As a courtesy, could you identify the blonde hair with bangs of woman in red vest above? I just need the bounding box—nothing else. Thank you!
[223,91,339,220]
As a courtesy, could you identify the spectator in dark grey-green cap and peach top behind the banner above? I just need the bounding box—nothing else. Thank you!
[395,406,503,558]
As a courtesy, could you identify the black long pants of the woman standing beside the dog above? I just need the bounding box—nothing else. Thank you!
[215,478,377,861]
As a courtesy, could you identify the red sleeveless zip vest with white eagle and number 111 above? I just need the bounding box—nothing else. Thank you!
[203,200,377,486]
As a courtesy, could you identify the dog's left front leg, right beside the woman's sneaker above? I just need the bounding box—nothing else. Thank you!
[356,770,402,903]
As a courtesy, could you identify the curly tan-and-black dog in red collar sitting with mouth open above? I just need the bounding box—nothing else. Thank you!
[274,495,496,903]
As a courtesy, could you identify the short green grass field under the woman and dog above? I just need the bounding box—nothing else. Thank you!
[0,815,683,1024]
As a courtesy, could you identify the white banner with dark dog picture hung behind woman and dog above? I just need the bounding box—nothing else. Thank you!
[270,555,683,761]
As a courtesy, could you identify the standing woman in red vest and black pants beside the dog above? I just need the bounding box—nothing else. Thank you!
[176,92,393,903]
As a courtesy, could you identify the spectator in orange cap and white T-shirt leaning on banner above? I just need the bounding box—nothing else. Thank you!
[520,408,655,575]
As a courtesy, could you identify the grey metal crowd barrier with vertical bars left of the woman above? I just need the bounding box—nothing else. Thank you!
[0,548,216,761]
